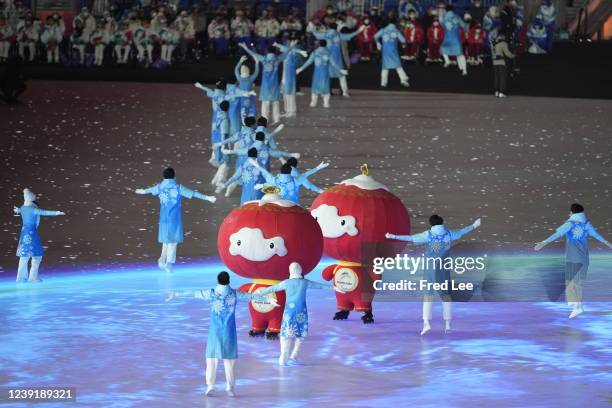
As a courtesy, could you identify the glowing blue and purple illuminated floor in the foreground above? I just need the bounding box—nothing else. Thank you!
[0,256,612,408]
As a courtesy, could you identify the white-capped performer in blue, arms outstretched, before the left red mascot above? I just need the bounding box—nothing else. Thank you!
[257,262,339,366]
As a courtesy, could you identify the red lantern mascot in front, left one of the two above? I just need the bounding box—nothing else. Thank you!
[217,187,322,339]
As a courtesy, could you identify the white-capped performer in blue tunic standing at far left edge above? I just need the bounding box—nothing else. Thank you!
[13,188,65,282]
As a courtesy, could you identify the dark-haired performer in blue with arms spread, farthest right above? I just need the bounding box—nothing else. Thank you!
[535,203,612,319]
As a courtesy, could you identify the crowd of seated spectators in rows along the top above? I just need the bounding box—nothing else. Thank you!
[0,0,555,68]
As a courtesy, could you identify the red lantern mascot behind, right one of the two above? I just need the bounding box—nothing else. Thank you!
[310,165,410,323]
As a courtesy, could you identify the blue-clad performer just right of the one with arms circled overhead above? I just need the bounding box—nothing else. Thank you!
[243,45,287,123]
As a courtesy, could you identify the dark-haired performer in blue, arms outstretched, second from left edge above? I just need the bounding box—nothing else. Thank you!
[136,167,217,272]
